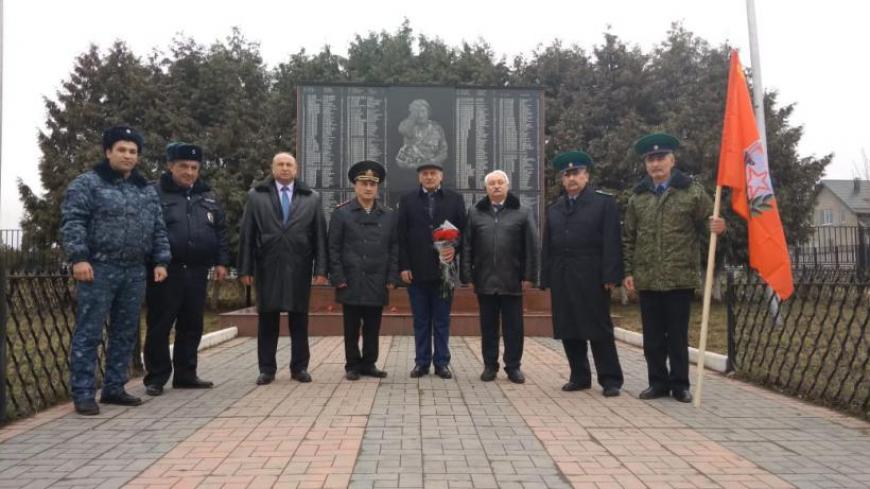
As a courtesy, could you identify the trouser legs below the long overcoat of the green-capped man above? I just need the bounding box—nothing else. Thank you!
[562,336,624,388]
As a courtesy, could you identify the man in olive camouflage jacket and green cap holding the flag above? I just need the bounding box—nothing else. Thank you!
[622,133,725,402]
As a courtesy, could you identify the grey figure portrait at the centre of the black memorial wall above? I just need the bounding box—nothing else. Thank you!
[396,99,447,169]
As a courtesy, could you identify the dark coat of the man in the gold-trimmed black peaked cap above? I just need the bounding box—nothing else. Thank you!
[329,198,400,307]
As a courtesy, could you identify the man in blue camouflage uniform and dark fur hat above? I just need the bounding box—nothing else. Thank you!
[61,126,171,415]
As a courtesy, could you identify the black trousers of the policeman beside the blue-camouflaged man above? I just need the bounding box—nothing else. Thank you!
[143,265,209,386]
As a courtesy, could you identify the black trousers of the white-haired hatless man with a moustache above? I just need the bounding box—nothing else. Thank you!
[477,294,524,370]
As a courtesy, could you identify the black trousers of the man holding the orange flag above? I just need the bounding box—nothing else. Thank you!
[639,289,693,390]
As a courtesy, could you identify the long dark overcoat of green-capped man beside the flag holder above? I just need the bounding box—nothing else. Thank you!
[541,186,623,341]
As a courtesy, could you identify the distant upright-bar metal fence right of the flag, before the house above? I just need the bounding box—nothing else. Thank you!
[789,226,870,273]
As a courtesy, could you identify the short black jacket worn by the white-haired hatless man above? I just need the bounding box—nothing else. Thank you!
[460,193,540,295]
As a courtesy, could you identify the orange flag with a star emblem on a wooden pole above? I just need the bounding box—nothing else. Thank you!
[717,51,794,300]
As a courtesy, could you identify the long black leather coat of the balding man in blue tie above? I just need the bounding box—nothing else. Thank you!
[239,177,327,312]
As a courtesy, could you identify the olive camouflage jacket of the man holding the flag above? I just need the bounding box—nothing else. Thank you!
[622,170,713,291]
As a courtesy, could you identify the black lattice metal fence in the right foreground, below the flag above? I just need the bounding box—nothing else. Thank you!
[727,269,870,417]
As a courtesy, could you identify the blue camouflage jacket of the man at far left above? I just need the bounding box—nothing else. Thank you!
[61,160,171,266]
